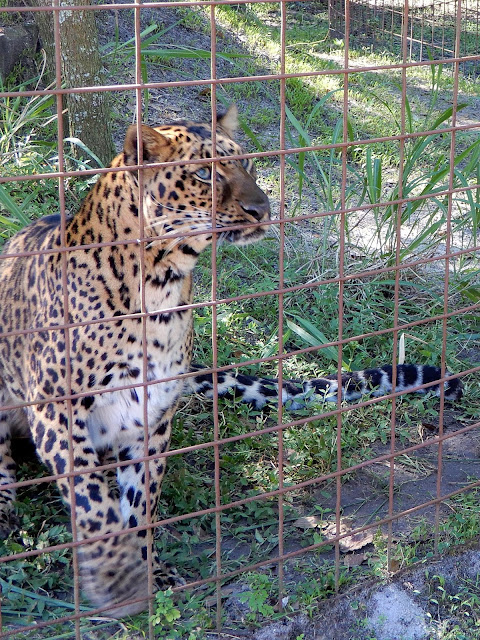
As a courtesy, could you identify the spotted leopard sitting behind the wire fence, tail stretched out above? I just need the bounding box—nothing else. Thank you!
[0,106,462,618]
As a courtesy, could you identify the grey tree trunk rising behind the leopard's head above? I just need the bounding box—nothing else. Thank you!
[32,0,115,164]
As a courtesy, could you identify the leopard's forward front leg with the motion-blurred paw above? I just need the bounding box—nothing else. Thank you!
[28,401,150,617]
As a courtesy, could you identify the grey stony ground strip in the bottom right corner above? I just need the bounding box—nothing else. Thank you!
[220,547,480,640]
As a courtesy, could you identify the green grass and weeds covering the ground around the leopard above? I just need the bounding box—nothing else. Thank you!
[0,3,480,640]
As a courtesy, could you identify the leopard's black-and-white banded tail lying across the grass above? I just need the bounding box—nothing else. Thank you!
[185,364,463,410]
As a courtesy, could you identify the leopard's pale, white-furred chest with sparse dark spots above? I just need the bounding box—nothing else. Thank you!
[79,278,192,449]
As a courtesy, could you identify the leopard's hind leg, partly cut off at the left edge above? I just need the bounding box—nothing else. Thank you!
[0,378,28,538]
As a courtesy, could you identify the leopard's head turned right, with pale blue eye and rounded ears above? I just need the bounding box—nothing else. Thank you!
[122,107,270,253]
